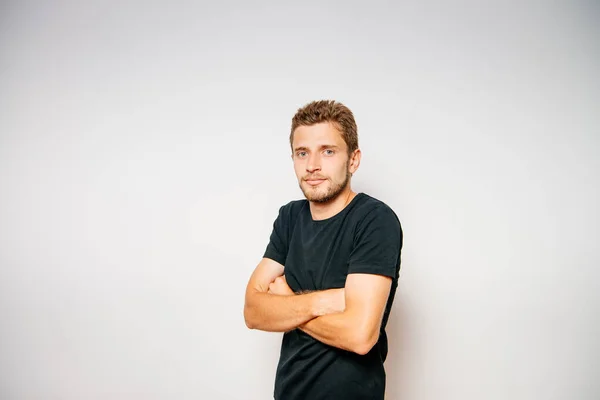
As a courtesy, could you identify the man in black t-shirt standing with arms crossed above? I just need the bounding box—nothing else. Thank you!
[244,101,402,400]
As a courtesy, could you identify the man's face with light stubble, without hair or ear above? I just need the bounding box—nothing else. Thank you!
[292,122,354,203]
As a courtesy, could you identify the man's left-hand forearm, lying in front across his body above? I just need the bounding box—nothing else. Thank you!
[244,289,343,332]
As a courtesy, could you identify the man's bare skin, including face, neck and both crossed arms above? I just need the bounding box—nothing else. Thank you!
[244,122,392,354]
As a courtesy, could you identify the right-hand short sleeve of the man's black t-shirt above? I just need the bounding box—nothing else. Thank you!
[348,205,402,278]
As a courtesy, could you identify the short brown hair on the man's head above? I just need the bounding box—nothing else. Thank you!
[290,100,358,154]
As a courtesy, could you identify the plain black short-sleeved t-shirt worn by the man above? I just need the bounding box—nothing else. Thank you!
[264,193,402,400]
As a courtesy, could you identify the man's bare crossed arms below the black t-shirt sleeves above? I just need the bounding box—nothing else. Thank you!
[244,258,392,354]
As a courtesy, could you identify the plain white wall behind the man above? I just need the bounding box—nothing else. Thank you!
[0,0,600,400]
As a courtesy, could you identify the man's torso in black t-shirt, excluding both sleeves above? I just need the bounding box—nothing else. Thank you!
[268,193,399,400]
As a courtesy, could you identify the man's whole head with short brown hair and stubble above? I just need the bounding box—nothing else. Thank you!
[290,100,361,203]
